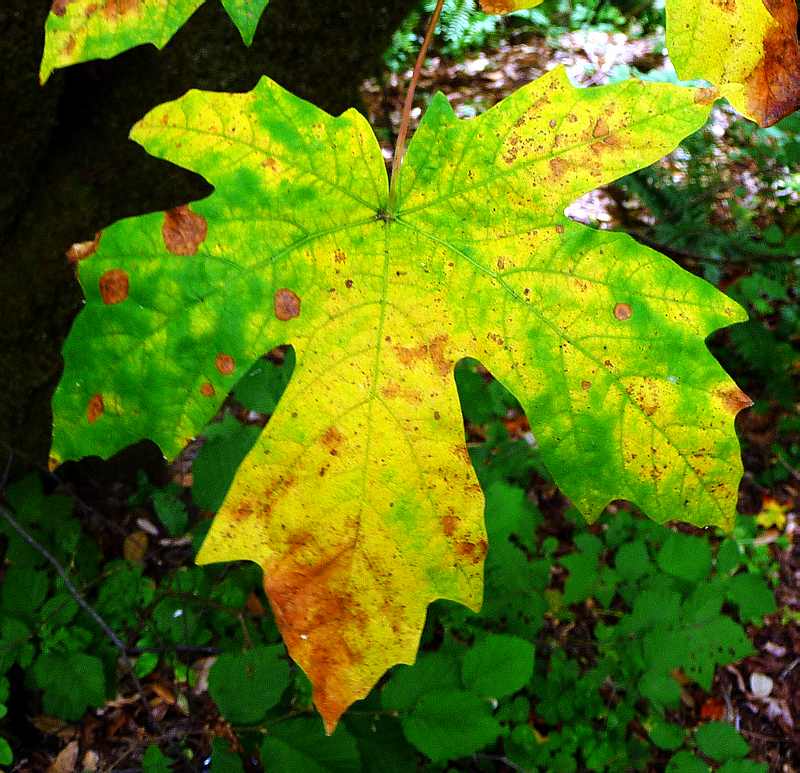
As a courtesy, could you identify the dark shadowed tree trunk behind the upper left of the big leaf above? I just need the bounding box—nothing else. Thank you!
[0,0,416,463]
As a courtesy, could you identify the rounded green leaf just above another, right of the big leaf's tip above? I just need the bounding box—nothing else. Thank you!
[461,634,534,698]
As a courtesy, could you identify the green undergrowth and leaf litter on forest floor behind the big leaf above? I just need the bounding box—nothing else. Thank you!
[0,0,800,773]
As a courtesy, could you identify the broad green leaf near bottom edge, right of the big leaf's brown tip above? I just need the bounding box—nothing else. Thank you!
[402,690,503,762]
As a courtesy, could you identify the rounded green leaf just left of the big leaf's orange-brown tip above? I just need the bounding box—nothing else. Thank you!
[208,644,289,725]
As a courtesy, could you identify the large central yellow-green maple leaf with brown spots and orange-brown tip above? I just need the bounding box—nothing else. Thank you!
[53,68,749,729]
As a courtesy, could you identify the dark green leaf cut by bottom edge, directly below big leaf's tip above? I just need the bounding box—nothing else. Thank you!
[261,717,361,773]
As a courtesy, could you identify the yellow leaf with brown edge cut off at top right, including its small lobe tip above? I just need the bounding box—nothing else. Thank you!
[481,0,800,126]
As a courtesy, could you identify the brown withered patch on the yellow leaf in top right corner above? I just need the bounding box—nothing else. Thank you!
[746,0,800,126]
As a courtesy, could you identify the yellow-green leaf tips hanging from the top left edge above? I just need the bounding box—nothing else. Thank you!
[39,0,269,83]
